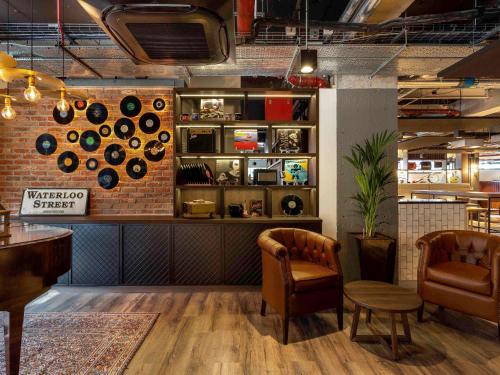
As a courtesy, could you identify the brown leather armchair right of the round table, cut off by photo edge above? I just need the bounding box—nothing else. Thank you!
[416,230,500,335]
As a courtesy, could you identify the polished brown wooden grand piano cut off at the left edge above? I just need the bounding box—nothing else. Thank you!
[0,222,73,375]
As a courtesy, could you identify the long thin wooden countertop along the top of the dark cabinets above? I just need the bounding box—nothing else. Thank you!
[17,215,322,224]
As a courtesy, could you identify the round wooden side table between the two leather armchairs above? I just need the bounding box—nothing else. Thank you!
[344,280,423,361]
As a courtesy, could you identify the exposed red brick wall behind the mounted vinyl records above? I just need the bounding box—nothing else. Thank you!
[0,89,173,215]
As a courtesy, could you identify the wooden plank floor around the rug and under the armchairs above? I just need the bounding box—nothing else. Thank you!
[27,287,500,375]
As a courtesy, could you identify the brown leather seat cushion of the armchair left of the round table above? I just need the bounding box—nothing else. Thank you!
[290,260,339,292]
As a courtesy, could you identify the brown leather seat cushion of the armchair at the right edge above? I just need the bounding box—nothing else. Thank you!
[427,262,491,295]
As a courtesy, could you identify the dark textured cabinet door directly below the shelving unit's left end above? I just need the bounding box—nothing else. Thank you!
[174,224,223,285]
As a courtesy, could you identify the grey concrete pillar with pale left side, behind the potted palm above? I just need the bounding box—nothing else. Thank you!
[319,76,398,281]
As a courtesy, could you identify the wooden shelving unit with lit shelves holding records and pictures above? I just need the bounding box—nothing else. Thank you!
[174,88,319,221]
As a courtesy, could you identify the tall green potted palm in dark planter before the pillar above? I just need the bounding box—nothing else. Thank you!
[344,131,398,283]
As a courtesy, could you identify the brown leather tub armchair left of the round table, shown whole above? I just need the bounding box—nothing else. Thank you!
[257,228,343,345]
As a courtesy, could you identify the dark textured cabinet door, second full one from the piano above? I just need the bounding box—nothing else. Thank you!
[122,224,172,285]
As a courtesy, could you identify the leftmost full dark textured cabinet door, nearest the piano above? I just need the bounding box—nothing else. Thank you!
[71,224,120,285]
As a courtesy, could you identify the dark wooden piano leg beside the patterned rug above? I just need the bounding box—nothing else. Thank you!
[4,308,24,375]
